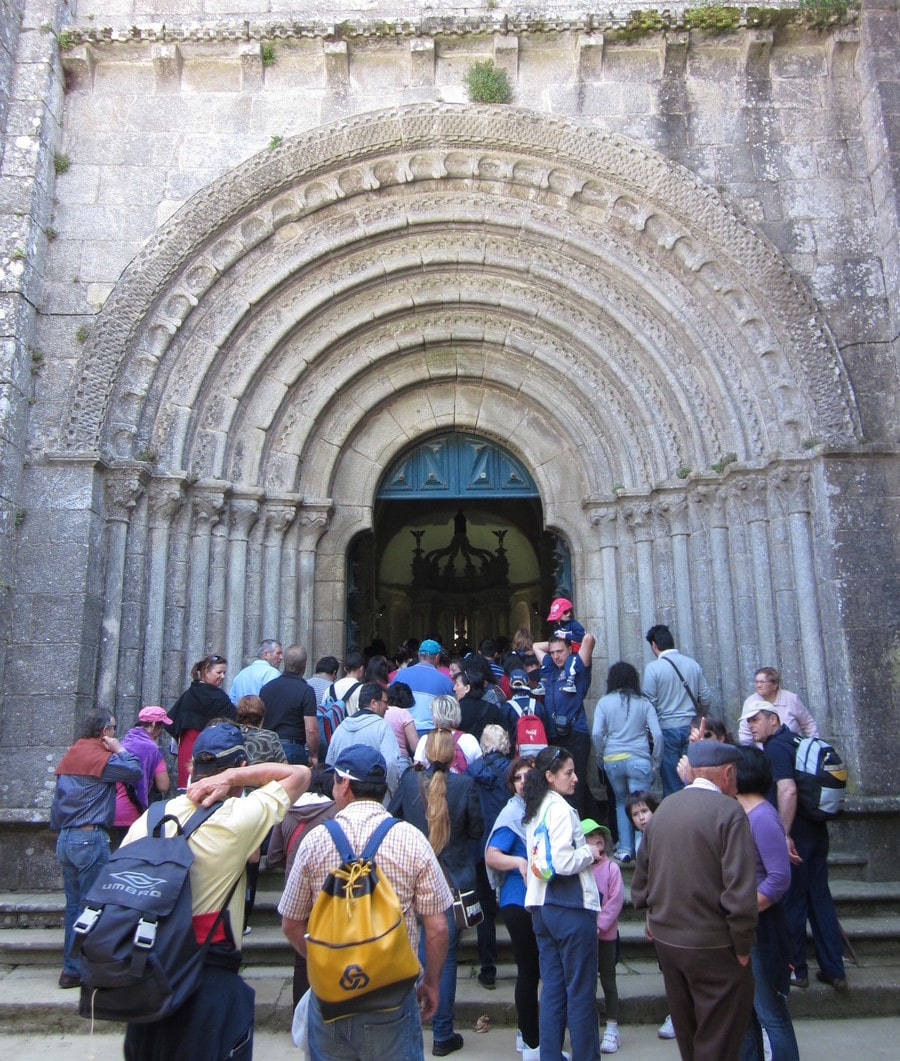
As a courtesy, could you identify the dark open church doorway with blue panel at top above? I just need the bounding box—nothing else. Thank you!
[346,432,569,653]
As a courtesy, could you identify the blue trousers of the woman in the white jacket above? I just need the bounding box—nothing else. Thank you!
[532,905,600,1061]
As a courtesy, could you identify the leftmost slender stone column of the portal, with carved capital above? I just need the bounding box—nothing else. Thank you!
[97,467,146,709]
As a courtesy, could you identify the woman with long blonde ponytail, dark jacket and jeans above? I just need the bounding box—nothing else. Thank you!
[390,729,484,1057]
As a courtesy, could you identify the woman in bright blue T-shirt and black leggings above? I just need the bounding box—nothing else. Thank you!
[484,755,540,1059]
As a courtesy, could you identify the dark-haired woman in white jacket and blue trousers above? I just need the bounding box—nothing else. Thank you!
[522,745,600,1061]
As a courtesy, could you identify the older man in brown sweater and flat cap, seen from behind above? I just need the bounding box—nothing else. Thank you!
[631,741,757,1061]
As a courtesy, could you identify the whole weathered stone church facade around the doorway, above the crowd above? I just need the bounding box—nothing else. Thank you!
[0,0,900,887]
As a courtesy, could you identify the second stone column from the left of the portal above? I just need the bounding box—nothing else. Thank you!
[141,479,185,703]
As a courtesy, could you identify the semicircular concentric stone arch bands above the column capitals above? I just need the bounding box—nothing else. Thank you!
[64,105,858,495]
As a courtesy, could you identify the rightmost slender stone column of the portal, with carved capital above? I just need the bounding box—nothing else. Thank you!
[774,468,830,727]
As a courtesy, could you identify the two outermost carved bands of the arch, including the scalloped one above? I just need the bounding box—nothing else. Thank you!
[64,104,859,473]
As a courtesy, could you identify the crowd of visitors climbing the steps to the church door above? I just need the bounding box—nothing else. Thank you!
[52,598,848,1061]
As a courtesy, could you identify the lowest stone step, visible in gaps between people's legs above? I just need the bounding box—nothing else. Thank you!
[0,959,900,1034]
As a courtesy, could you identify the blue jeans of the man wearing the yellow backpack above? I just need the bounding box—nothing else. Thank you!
[307,988,425,1061]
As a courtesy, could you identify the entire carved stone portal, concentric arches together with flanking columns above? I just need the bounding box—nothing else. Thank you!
[50,105,860,755]
